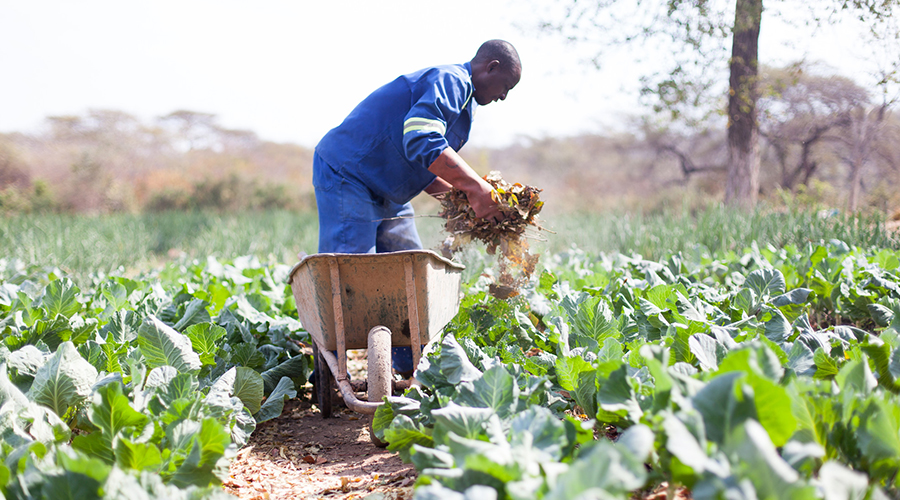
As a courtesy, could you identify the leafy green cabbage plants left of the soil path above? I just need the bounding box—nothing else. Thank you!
[0,258,311,499]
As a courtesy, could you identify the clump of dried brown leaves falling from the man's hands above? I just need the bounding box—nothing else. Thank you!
[440,172,544,299]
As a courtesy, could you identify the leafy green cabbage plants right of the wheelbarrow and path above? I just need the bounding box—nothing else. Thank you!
[374,241,900,500]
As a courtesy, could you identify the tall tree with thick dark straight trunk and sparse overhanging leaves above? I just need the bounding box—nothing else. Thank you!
[542,0,900,207]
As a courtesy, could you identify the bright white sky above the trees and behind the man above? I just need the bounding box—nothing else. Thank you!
[0,0,884,147]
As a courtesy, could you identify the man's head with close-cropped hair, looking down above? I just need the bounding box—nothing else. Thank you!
[472,40,522,106]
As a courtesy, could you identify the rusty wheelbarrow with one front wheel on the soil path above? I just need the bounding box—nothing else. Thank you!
[289,250,465,434]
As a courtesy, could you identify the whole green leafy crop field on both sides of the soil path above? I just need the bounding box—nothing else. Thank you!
[0,214,900,500]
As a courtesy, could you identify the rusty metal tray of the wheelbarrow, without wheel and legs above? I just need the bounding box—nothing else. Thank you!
[289,250,464,352]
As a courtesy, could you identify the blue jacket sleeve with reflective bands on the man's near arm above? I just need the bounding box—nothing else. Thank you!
[403,72,471,168]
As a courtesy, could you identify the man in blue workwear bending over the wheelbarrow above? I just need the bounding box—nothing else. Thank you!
[313,40,522,377]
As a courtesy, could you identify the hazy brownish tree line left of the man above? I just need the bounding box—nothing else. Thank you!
[0,109,313,213]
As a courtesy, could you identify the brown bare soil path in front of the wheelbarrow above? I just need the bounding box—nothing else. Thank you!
[224,356,416,500]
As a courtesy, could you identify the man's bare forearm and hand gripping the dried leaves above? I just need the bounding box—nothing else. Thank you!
[426,148,503,222]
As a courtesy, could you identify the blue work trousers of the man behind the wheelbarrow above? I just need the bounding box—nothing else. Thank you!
[313,154,422,373]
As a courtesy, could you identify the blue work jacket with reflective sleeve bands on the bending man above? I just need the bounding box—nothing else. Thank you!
[313,63,475,203]
